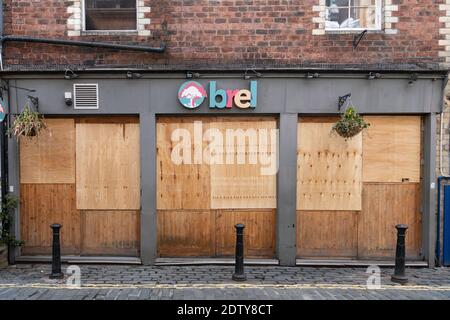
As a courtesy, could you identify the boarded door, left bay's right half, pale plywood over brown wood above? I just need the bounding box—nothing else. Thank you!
[76,117,141,256]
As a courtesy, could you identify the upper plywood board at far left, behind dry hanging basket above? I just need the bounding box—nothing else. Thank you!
[20,119,75,184]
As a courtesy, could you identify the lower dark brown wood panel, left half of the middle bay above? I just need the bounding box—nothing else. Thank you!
[157,210,215,257]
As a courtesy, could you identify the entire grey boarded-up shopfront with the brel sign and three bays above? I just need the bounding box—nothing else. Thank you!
[3,69,446,266]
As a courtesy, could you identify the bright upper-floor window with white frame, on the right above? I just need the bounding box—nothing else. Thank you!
[325,0,382,31]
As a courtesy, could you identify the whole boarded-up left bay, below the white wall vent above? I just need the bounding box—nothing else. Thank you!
[20,117,140,256]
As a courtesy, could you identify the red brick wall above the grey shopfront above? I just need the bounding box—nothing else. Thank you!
[1,0,445,66]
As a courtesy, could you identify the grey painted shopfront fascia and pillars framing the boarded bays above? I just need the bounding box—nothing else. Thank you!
[3,71,445,266]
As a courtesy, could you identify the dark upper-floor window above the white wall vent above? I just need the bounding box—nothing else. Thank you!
[84,0,137,31]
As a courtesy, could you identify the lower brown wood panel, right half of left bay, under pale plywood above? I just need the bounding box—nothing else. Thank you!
[81,211,140,256]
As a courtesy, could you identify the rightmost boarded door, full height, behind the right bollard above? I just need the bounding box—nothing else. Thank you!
[358,116,422,259]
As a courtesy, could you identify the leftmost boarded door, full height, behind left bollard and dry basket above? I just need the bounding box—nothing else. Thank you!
[19,119,80,255]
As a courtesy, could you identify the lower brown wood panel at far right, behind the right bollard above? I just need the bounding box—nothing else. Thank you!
[358,183,422,259]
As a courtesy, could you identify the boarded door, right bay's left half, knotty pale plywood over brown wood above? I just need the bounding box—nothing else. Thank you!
[297,117,362,258]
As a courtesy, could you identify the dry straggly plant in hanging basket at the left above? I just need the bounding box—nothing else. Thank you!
[8,103,47,139]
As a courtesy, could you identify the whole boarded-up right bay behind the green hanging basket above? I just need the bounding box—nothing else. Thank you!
[297,116,422,259]
